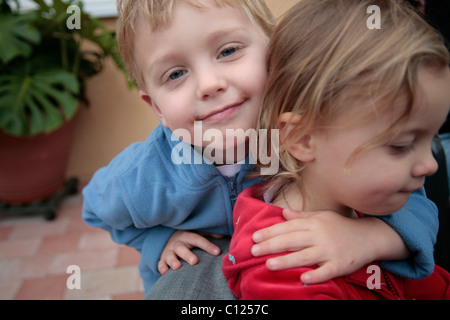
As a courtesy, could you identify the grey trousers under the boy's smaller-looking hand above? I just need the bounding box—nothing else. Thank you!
[144,238,236,300]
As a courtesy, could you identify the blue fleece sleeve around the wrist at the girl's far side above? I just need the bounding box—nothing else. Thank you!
[380,188,439,280]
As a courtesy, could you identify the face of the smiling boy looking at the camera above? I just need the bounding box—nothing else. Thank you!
[135,1,267,150]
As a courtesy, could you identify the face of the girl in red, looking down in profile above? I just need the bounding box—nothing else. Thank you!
[303,68,450,215]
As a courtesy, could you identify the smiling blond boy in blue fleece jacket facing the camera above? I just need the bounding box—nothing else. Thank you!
[83,0,273,291]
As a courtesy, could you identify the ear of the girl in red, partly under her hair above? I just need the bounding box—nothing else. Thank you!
[279,112,315,162]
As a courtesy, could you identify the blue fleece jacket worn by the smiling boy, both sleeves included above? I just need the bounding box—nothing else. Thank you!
[83,125,438,291]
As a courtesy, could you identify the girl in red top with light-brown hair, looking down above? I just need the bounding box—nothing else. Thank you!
[223,0,450,299]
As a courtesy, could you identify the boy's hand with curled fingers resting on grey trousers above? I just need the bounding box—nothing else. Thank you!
[158,230,223,274]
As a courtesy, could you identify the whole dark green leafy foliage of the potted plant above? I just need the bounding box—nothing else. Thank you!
[0,0,131,135]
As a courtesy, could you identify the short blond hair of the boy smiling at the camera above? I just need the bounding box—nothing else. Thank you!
[116,0,275,86]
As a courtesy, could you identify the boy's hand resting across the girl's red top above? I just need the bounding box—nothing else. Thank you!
[252,209,407,284]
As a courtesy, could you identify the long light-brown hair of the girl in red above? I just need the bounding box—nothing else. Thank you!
[257,0,449,190]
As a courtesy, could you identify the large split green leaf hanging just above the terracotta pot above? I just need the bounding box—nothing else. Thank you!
[0,70,79,135]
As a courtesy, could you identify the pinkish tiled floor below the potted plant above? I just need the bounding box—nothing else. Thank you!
[0,180,144,300]
